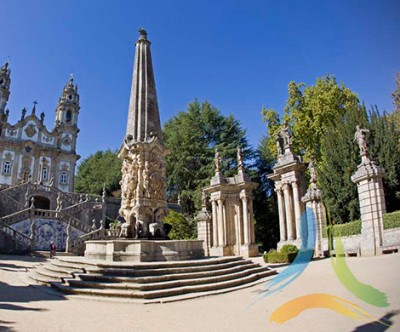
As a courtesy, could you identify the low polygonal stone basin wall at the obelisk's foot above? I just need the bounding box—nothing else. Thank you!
[85,239,204,262]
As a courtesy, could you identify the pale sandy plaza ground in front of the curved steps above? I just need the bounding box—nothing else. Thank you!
[0,254,400,332]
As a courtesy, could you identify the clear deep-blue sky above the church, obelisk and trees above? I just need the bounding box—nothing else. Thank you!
[0,0,400,158]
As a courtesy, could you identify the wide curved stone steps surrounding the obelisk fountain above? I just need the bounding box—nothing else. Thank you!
[29,257,276,303]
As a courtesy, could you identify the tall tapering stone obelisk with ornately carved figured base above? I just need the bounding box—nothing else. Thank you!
[118,29,168,238]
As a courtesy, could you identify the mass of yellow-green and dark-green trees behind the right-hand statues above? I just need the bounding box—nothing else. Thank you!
[262,76,400,224]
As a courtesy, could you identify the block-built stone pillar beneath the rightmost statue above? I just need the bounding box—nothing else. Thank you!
[351,161,386,256]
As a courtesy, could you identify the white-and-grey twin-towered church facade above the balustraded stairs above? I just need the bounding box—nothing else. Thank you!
[0,62,80,192]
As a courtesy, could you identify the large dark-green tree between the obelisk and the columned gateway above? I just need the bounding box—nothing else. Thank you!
[163,100,252,216]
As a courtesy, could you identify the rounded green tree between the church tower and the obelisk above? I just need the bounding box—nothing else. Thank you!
[75,150,122,196]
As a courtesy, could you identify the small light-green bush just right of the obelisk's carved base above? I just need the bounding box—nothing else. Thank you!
[164,210,197,240]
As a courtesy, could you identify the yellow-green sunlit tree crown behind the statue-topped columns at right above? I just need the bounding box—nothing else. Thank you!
[262,76,359,162]
